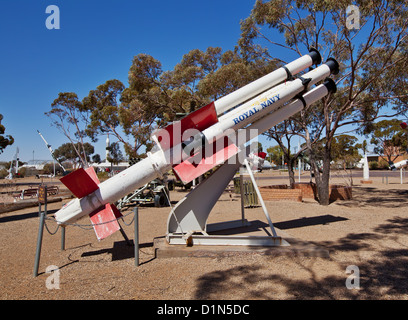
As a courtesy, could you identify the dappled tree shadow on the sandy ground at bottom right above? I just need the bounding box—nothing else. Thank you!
[194,217,408,299]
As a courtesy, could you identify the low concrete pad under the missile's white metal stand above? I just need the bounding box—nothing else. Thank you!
[153,221,330,259]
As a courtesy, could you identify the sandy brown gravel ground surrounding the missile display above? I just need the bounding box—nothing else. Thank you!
[0,172,408,300]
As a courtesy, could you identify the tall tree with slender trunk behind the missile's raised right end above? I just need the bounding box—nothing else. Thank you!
[239,0,408,204]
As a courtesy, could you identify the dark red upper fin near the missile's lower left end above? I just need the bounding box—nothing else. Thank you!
[60,167,99,199]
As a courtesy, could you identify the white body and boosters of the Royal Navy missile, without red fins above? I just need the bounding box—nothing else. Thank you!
[55,50,338,238]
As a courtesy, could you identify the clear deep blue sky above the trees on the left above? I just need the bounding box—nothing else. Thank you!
[0,0,264,161]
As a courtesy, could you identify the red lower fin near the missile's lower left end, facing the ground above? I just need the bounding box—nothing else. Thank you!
[89,203,122,240]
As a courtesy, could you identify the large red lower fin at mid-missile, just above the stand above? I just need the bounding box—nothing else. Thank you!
[173,137,239,183]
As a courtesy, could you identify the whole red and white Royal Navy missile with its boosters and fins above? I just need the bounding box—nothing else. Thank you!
[55,51,338,239]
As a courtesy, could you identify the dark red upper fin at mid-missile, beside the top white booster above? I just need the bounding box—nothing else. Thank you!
[155,102,218,150]
